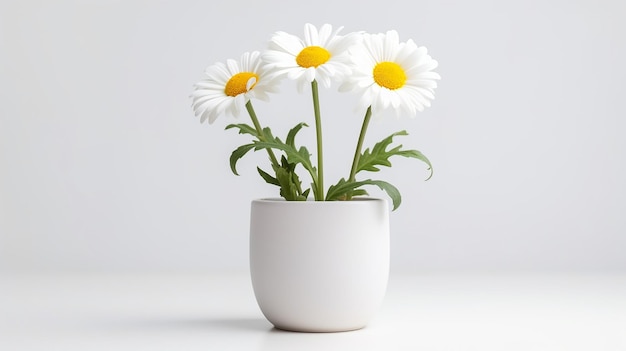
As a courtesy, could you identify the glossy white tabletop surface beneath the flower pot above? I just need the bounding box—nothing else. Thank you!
[0,272,626,351]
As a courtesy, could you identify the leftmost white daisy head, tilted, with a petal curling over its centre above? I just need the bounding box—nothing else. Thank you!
[191,51,277,124]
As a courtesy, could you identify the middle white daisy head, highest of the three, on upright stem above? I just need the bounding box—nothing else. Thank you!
[263,23,360,91]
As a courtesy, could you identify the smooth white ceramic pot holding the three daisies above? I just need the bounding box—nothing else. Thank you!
[250,198,389,332]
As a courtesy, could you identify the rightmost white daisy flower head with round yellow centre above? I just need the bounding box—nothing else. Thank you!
[340,30,441,116]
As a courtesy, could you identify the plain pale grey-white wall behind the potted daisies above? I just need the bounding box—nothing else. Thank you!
[0,0,626,272]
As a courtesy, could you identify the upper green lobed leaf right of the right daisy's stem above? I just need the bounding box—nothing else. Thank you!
[357,130,433,180]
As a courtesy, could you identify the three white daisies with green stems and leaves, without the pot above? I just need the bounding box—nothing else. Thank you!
[191,24,440,210]
